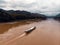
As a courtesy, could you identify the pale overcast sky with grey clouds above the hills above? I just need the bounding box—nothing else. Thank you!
[0,0,60,16]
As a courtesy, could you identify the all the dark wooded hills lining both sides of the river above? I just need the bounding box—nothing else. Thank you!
[0,9,60,22]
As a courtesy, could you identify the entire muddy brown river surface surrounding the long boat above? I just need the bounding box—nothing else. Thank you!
[0,19,60,45]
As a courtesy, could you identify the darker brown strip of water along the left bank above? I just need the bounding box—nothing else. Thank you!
[0,20,37,34]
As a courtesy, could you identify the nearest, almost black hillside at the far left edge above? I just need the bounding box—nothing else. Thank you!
[0,9,12,22]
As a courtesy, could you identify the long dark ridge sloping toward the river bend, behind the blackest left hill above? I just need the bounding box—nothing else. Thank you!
[7,10,46,20]
